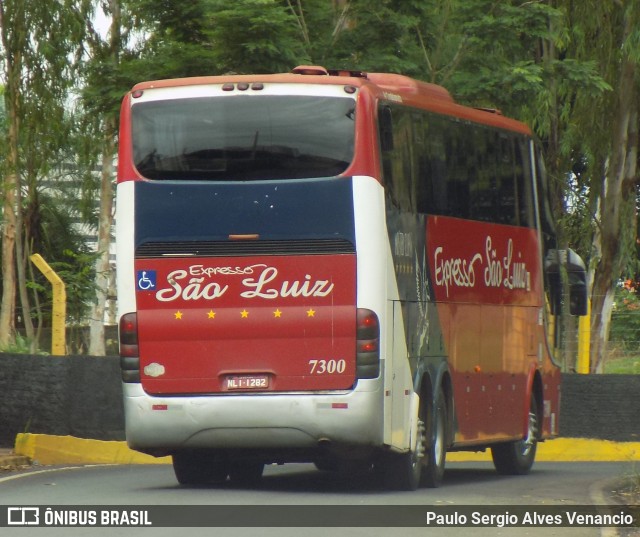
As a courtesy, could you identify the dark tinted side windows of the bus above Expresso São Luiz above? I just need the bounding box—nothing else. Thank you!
[382,105,535,227]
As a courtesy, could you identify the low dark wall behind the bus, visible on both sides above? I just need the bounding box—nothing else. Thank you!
[0,354,640,447]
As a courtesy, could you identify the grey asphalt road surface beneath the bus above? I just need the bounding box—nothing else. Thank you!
[0,463,637,537]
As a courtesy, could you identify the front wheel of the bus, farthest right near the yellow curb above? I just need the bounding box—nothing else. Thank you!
[491,395,539,475]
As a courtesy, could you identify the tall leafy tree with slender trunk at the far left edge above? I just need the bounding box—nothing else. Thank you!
[0,0,89,347]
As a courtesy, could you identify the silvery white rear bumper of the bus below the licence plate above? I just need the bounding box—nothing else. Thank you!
[123,380,383,455]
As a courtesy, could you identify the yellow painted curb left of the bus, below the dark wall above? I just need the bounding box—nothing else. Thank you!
[14,434,171,464]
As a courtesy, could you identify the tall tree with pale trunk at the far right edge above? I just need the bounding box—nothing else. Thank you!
[559,0,640,372]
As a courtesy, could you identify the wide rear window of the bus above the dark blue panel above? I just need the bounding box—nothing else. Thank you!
[132,95,355,181]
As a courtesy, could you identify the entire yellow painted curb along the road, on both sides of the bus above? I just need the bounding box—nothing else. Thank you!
[8,433,640,467]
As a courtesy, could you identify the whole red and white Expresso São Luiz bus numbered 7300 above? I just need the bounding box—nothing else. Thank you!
[116,66,586,489]
